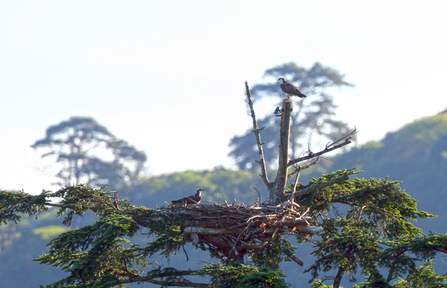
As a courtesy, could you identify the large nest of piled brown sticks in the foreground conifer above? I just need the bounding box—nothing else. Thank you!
[138,202,322,259]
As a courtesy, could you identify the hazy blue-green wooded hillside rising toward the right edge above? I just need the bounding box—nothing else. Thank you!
[310,110,447,233]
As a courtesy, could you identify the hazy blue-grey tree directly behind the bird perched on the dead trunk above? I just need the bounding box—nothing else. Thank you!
[229,62,355,170]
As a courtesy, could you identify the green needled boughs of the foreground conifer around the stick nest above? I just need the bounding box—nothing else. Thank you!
[0,171,447,287]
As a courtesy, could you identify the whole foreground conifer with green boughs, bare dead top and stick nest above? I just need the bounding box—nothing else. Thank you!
[0,75,447,288]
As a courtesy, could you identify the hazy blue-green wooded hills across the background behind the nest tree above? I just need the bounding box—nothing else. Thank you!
[0,110,447,288]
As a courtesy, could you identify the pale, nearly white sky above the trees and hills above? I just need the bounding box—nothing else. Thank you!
[0,0,447,193]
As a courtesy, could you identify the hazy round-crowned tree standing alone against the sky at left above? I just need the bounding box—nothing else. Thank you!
[31,117,147,189]
